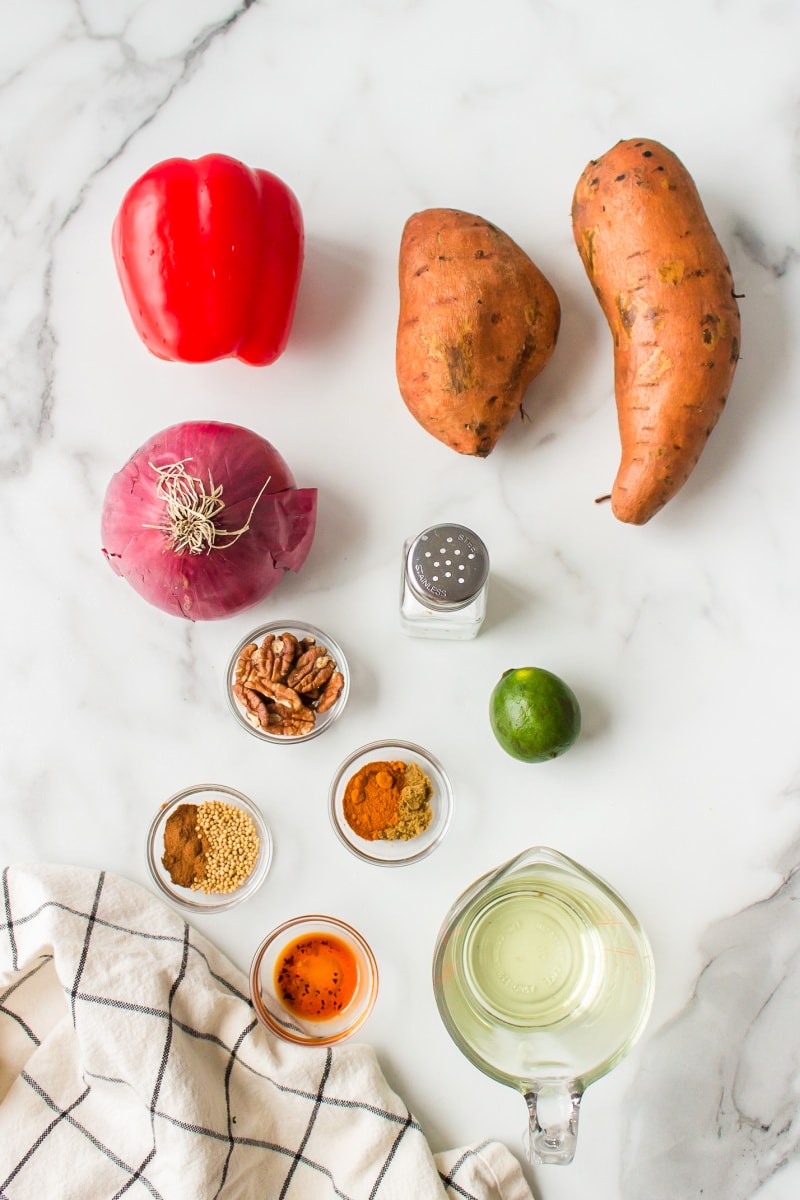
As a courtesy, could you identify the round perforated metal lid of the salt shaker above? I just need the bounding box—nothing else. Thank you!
[405,524,489,612]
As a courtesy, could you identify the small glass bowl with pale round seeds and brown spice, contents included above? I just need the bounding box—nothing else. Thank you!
[148,784,272,913]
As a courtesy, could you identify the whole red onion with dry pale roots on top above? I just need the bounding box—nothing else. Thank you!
[102,421,317,620]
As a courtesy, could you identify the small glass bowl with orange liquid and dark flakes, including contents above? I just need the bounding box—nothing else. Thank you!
[249,913,378,1046]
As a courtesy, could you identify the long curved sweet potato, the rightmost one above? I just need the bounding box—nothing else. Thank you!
[572,138,740,524]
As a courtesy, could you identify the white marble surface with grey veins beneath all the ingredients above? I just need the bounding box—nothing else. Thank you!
[0,0,800,1200]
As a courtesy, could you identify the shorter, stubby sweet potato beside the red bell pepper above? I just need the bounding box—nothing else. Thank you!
[396,209,561,458]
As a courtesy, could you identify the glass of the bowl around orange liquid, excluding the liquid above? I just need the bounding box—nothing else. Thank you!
[249,914,378,1046]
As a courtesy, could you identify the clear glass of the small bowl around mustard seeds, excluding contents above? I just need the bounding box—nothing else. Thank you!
[148,784,272,913]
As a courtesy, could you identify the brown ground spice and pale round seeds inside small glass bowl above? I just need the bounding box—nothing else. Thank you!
[161,800,260,894]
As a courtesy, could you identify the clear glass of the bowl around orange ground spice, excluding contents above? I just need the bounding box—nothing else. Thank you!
[329,740,453,866]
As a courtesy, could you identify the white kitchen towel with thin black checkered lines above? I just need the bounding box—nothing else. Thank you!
[0,866,533,1200]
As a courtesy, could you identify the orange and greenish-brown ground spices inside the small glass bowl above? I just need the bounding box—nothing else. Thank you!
[342,760,433,841]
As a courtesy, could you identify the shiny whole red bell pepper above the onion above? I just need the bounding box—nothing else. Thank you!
[112,154,303,366]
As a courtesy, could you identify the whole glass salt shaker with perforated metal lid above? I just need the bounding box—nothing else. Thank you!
[401,524,489,640]
